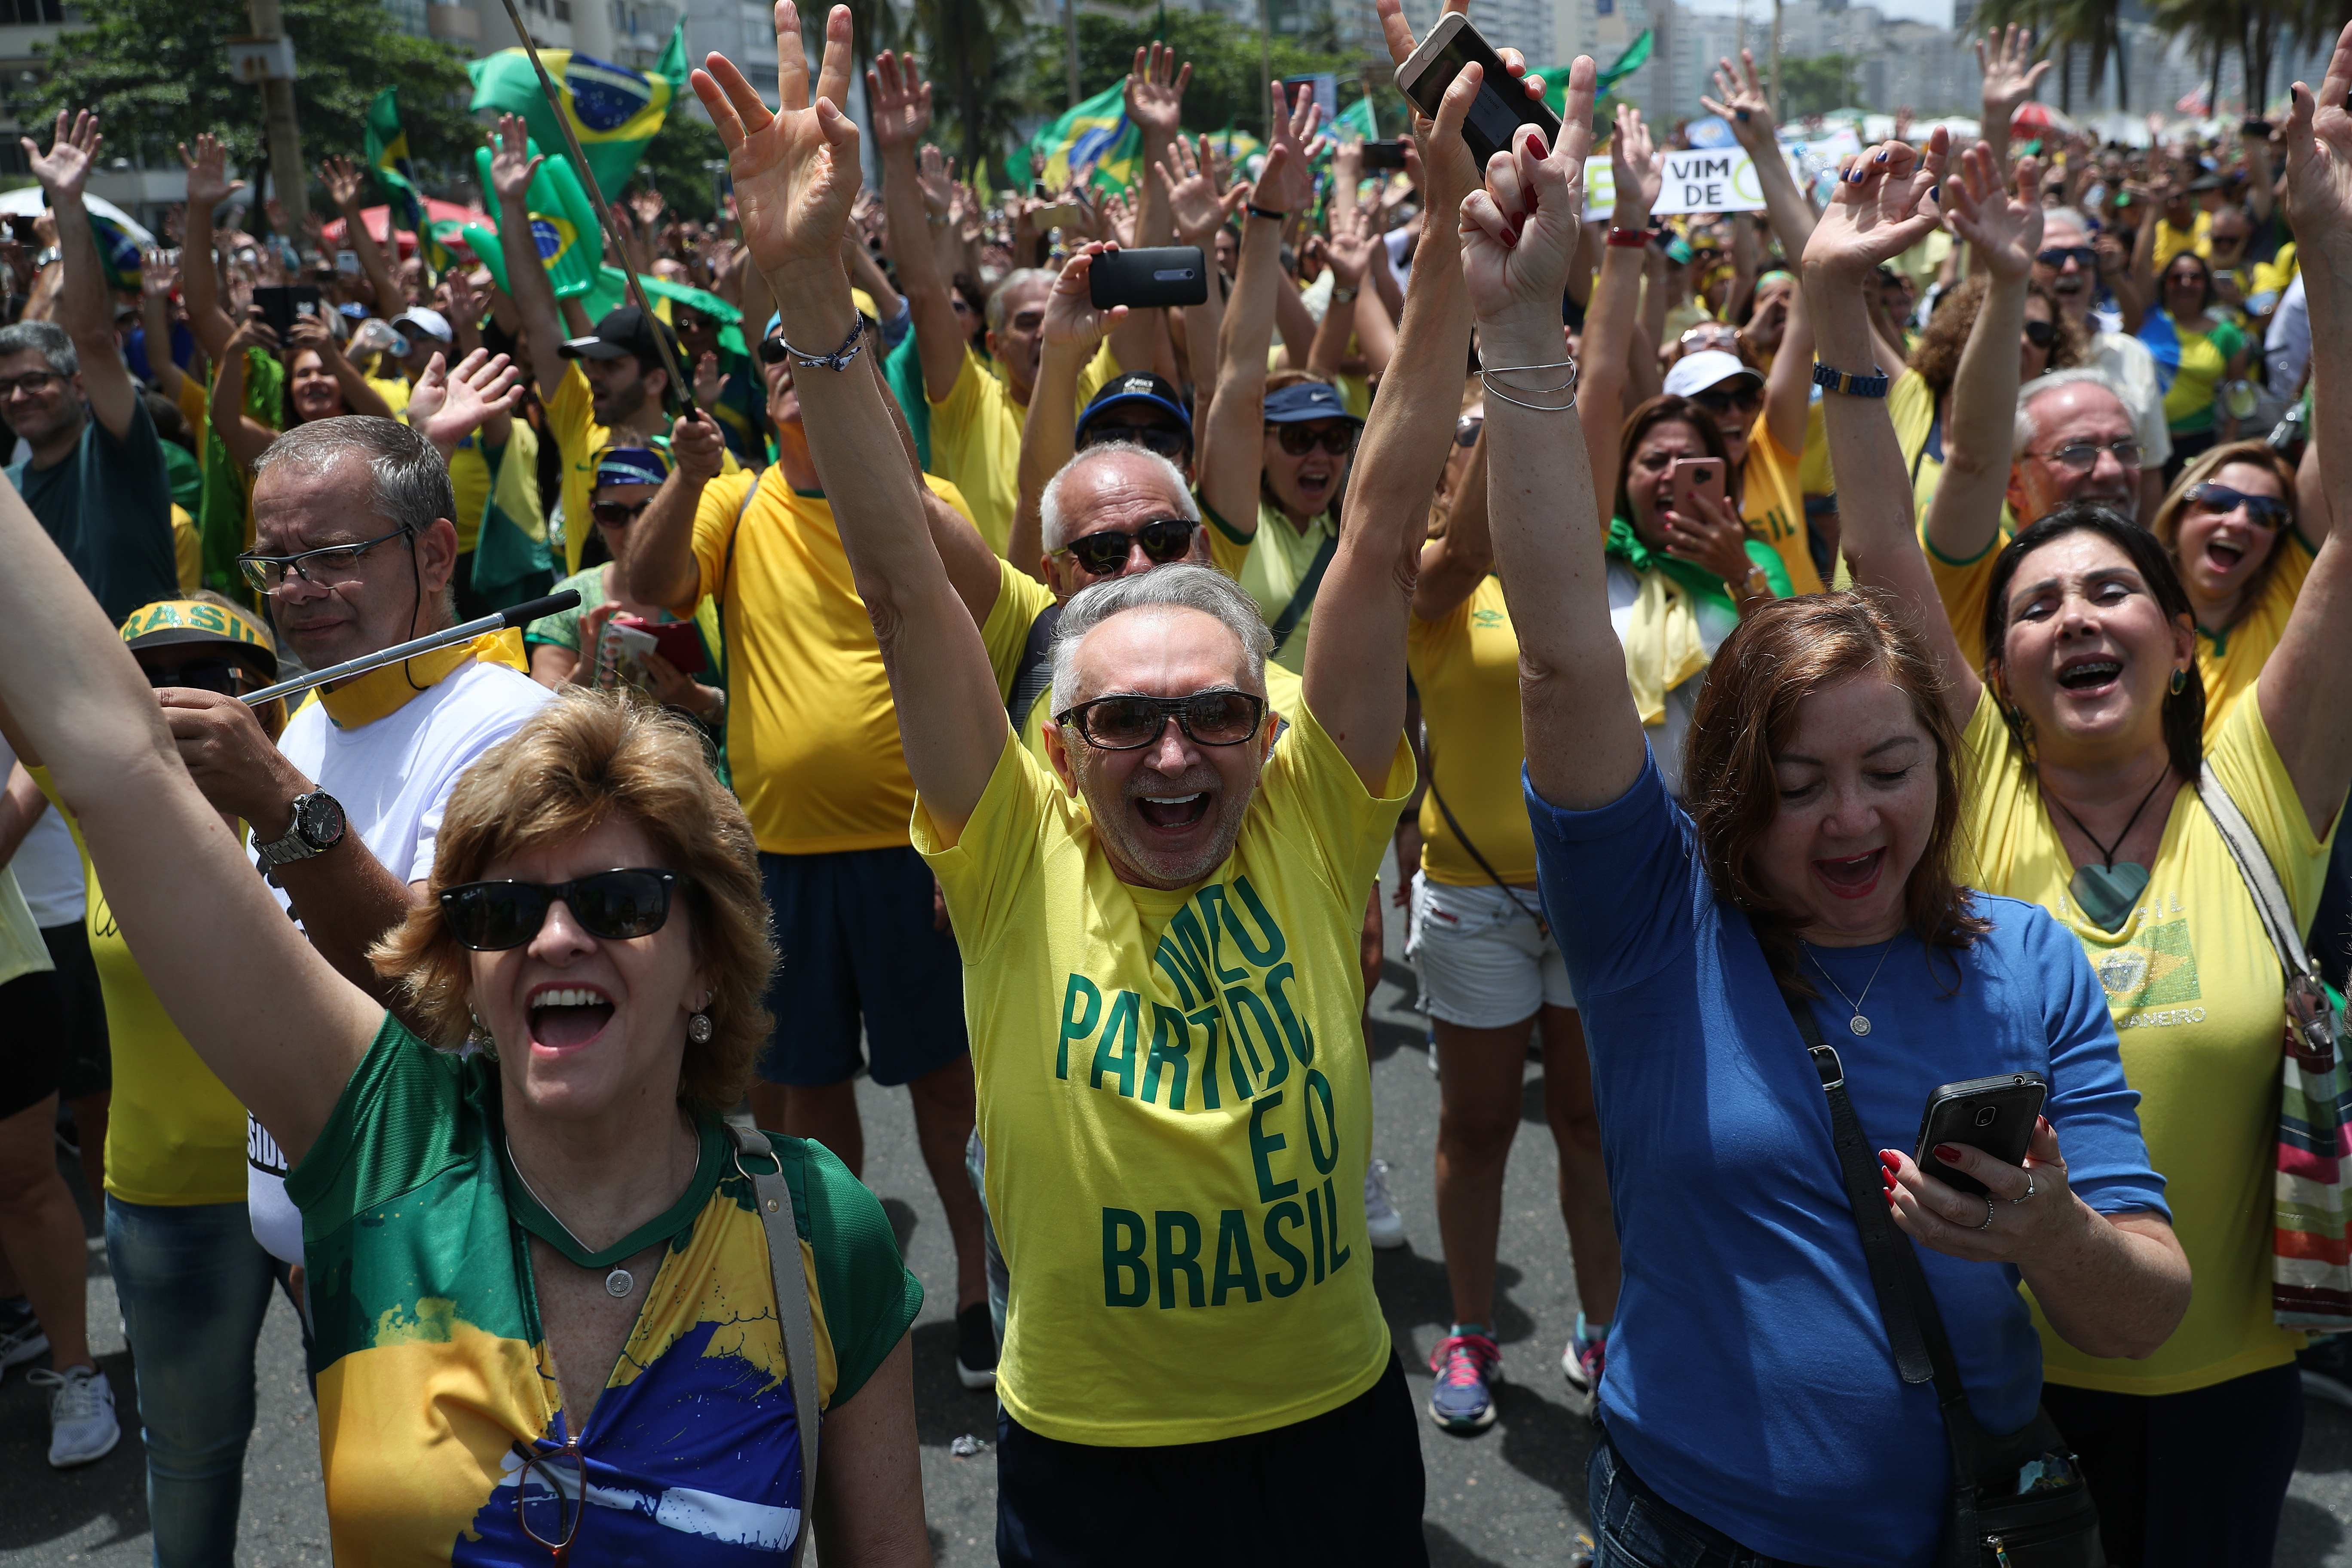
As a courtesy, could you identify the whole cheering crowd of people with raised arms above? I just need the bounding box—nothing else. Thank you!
[0,0,2352,1568]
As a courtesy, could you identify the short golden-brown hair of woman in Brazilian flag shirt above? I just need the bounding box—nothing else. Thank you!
[367,686,776,1114]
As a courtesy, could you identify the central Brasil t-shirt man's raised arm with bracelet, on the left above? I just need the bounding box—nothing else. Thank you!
[694,0,1007,839]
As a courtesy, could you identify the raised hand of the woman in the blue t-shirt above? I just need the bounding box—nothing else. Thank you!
[1458,54,1597,329]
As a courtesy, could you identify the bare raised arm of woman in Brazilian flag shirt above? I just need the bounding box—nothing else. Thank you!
[0,472,383,1161]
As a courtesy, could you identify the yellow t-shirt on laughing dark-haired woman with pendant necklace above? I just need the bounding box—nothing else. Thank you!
[1959,691,2328,1394]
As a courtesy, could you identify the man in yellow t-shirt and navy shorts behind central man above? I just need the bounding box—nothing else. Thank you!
[621,322,1000,1387]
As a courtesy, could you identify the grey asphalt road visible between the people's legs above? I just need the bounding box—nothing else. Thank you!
[14,851,2352,1568]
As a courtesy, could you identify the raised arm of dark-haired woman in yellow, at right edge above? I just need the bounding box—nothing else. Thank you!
[2260,24,2352,832]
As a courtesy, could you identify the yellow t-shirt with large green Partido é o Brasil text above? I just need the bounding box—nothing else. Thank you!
[915,712,1414,1439]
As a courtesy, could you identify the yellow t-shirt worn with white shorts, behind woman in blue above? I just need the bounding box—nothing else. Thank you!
[1404,574,1536,886]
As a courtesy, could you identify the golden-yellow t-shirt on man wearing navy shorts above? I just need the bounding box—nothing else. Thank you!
[686,466,992,856]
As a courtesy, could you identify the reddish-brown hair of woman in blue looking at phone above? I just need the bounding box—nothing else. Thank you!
[1681,590,1992,997]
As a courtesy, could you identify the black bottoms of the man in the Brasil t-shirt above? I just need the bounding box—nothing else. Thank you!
[997,1357,1430,1568]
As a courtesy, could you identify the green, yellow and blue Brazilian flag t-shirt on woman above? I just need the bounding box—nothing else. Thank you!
[287,1016,922,1568]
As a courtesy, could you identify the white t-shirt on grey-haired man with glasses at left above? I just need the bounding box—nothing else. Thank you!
[245,663,555,1262]
